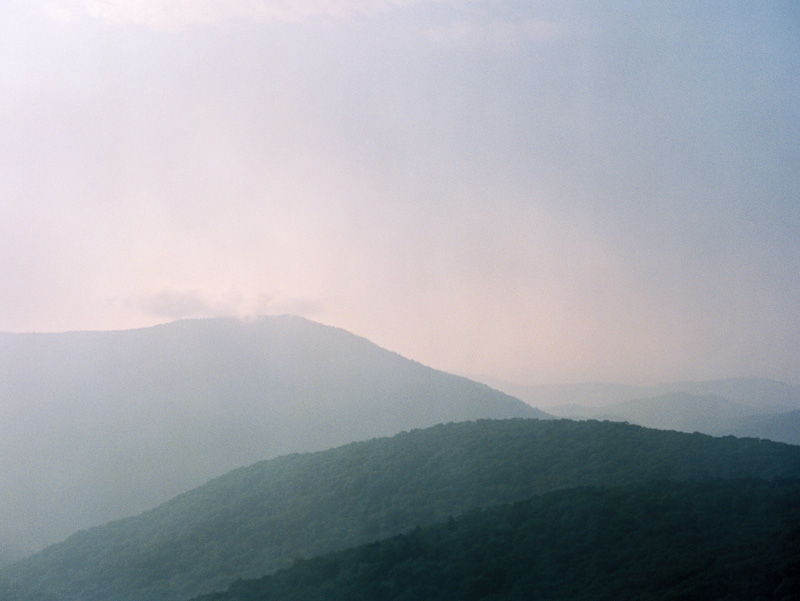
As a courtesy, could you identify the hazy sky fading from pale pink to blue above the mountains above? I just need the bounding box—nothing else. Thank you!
[0,0,800,383]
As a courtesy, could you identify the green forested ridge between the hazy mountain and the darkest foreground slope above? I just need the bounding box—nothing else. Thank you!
[0,419,800,601]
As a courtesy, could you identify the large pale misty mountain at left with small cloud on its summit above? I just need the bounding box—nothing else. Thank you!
[0,316,547,559]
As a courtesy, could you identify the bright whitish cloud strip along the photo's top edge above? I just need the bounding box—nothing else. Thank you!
[37,0,462,31]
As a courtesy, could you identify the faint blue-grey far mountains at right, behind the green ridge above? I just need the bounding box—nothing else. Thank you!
[492,378,800,444]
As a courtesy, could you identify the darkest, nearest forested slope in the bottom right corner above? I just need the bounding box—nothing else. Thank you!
[196,480,800,601]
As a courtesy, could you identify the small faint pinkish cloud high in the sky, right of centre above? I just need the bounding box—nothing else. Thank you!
[426,19,567,49]
